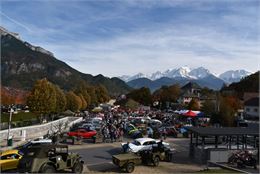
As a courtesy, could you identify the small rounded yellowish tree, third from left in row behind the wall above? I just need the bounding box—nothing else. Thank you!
[66,91,82,112]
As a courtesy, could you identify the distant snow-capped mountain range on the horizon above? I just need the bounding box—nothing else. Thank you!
[119,66,251,91]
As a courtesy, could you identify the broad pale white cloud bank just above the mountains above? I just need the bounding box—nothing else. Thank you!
[40,18,260,76]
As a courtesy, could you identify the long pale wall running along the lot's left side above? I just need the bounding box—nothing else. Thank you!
[0,117,83,141]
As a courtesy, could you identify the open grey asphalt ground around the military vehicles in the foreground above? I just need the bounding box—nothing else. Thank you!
[70,138,204,173]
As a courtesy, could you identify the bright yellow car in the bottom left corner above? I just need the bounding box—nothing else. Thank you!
[0,150,23,172]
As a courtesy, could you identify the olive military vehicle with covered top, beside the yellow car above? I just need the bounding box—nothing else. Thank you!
[18,145,84,173]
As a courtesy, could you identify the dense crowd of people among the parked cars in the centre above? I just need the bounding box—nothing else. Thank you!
[82,110,210,142]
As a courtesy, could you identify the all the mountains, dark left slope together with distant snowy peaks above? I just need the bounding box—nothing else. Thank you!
[0,27,253,95]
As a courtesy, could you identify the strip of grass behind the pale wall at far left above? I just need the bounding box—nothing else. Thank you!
[1,112,38,123]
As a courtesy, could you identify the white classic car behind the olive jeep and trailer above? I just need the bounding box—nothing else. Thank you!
[121,138,170,153]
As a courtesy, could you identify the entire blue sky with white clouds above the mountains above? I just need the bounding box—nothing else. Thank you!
[0,0,260,77]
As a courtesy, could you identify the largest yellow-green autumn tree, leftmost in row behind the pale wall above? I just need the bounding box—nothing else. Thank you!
[27,78,57,115]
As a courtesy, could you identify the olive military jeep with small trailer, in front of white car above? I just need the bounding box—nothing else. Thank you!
[112,150,165,173]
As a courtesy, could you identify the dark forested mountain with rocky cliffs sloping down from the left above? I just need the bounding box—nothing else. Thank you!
[0,27,131,95]
